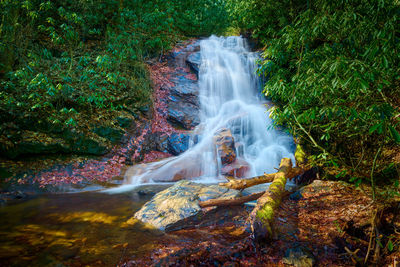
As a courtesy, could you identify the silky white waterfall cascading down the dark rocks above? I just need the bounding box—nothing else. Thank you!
[106,36,294,195]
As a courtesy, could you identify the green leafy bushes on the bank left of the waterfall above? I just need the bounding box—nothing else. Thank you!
[0,0,228,157]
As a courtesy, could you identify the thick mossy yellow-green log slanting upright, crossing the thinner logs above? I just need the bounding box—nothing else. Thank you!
[249,158,293,241]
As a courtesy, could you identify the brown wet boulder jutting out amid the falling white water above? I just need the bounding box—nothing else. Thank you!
[214,128,236,165]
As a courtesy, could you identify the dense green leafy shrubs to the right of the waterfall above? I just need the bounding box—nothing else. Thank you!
[233,0,400,183]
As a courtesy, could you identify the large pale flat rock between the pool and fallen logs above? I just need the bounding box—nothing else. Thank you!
[134,181,239,231]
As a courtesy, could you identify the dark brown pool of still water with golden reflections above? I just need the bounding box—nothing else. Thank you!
[0,190,163,266]
